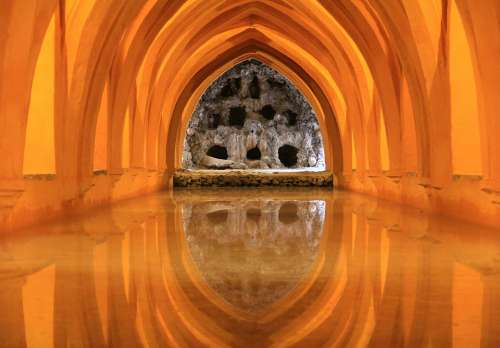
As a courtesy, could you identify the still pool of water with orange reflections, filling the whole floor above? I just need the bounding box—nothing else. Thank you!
[0,189,500,347]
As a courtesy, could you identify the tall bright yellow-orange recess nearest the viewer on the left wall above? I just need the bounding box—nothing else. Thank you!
[23,16,55,174]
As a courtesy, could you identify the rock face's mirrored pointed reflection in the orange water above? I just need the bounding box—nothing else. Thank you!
[182,199,325,312]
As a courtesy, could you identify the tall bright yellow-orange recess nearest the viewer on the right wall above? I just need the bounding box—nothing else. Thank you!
[450,1,482,175]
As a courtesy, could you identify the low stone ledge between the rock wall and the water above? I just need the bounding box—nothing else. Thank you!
[174,169,333,187]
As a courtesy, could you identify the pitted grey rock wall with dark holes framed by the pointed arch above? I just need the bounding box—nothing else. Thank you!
[183,59,325,169]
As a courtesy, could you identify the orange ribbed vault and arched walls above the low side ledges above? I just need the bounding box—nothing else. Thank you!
[0,0,500,228]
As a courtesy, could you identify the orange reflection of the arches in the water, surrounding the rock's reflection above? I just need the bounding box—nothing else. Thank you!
[0,191,500,347]
